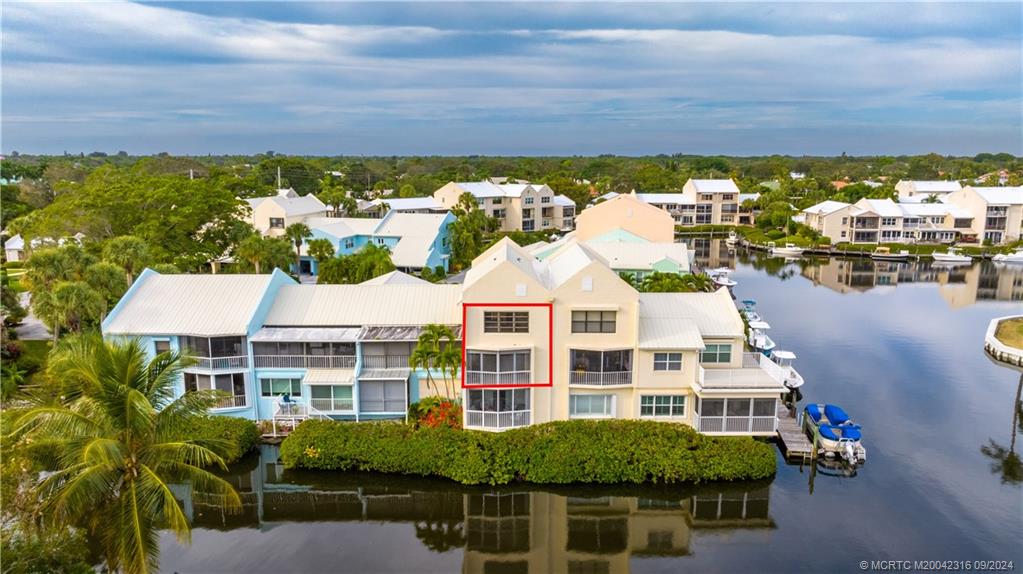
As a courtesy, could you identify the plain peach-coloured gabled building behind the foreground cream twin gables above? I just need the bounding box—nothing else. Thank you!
[575,193,675,244]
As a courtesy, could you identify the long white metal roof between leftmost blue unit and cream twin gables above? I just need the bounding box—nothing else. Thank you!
[264,283,461,326]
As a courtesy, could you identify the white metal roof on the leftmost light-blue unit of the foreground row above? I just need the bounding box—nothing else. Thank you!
[104,271,280,337]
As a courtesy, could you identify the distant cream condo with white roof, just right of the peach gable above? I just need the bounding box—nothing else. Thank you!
[599,179,754,227]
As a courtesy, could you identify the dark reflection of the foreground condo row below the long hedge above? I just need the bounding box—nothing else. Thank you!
[169,446,774,574]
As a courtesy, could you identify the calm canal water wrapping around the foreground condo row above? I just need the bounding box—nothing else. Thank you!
[162,240,1023,574]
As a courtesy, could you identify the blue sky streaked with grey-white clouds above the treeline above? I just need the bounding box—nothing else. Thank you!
[0,0,1023,156]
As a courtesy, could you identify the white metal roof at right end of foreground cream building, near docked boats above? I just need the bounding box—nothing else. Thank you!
[639,288,743,338]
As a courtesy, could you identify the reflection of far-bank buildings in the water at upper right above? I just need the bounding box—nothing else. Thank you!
[685,237,1023,309]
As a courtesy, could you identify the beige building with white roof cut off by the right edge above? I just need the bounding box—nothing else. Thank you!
[944,186,1023,245]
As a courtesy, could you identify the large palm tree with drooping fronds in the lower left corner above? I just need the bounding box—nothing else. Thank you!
[9,337,240,574]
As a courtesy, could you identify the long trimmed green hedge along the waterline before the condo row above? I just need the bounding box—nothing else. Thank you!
[280,420,775,484]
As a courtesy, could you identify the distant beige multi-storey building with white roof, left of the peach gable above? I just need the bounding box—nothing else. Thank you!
[434,180,575,231]
